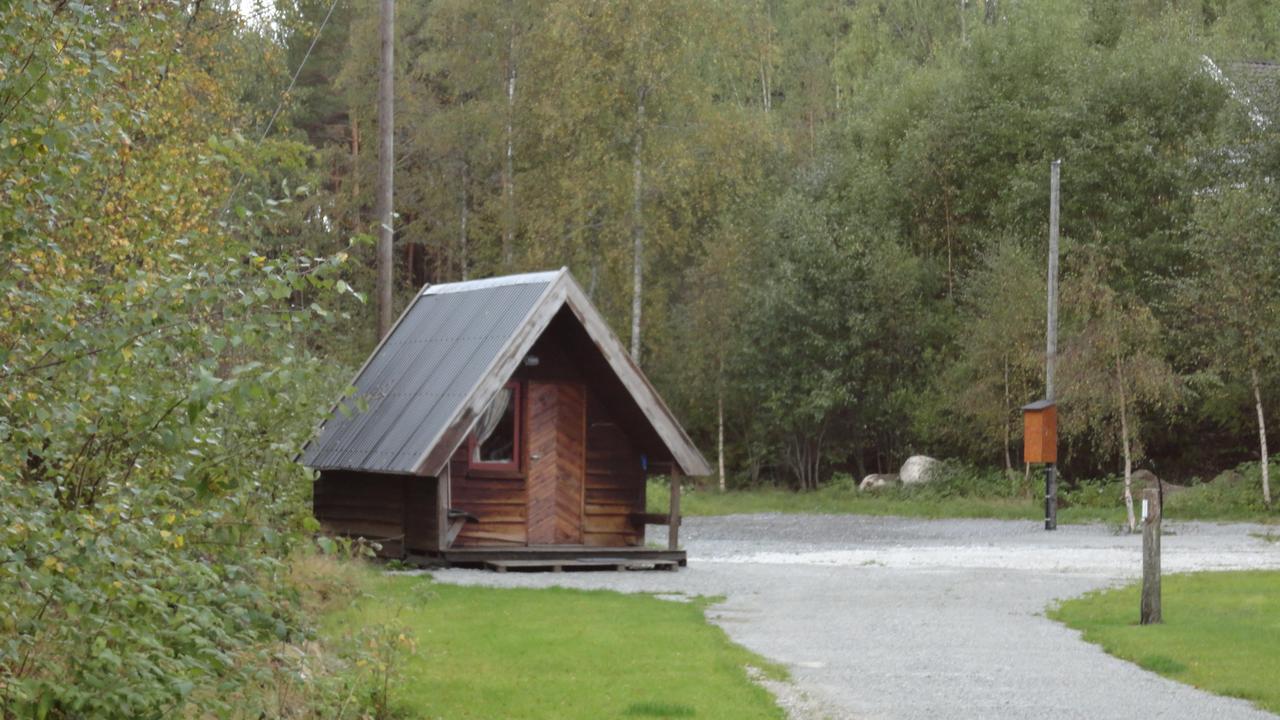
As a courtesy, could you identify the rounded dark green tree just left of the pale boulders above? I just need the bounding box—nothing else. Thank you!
[731,191,928,489]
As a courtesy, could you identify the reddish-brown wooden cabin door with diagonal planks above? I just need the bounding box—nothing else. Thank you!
[525,380,586,544]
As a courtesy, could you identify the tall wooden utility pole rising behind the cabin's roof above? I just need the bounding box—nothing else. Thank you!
[378,0,396,340]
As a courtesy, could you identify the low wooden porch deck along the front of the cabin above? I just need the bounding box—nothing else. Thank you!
[406,544,689,573]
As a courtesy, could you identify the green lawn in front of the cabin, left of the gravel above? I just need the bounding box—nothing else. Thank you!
[323,577,783,720]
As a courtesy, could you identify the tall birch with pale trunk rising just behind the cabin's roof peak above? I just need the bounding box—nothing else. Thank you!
[530,0,747,364]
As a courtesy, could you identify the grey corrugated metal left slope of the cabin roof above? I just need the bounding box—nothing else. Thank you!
[302,273,559,473]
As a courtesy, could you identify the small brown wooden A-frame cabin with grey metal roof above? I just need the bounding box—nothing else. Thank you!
[302,269,710,565]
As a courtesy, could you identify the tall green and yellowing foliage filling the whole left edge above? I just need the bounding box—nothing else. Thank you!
[0,3,371,717]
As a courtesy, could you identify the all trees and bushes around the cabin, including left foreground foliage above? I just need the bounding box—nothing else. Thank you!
[0,0,1280,717]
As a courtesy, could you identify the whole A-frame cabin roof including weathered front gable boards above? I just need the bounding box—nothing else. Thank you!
[302,268,710,475]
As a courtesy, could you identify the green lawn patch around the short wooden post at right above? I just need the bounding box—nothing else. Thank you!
[1050,571,1280,712]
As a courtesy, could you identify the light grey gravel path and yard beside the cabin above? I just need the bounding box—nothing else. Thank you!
[434,514,1280,720]
